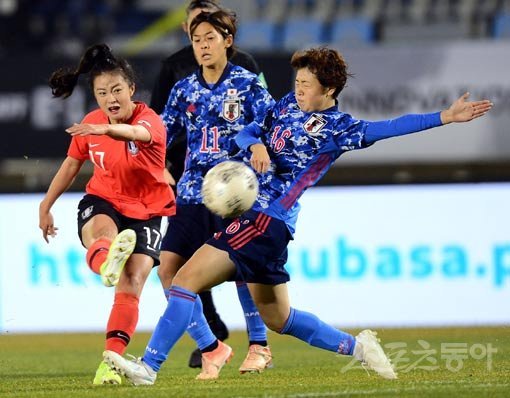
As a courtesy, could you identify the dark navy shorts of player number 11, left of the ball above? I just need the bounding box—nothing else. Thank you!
[161,204,232,259]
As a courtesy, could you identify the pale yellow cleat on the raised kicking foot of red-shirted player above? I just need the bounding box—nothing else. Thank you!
[99,229,136,287]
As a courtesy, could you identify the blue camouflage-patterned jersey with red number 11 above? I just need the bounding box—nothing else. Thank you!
[161,62,274,204]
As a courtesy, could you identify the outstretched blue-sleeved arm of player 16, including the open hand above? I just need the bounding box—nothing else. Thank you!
[365,93,493,144]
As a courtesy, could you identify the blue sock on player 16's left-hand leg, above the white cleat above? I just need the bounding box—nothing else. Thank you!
[142,286,198,372]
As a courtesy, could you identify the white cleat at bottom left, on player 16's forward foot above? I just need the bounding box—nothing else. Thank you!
[103,351,158,386]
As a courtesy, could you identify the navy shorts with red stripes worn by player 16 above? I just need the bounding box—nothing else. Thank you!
[207,210,292,285]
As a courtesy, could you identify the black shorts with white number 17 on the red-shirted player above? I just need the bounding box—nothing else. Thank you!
[78,194,162,266]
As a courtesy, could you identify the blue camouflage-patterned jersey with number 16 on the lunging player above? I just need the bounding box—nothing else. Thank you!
[236,92,369,233]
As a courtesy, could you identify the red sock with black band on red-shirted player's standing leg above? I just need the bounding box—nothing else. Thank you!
[105,293,139,355]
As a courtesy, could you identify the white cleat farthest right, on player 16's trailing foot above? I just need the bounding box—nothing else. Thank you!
[353,330,397,379]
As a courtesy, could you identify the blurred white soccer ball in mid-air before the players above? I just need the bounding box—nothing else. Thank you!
[202,160,259,218]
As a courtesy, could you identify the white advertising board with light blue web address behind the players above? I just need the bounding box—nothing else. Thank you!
[0,184,510,333]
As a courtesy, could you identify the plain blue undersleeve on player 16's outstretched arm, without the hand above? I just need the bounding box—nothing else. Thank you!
[365,112,442,144]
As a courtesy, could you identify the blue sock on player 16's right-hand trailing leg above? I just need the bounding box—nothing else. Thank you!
[280,308,355,355]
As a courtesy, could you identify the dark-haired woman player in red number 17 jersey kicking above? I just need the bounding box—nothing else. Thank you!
[39,44,175,384]
